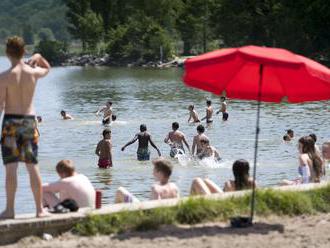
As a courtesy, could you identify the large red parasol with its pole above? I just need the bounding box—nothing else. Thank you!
[183,46,330,223]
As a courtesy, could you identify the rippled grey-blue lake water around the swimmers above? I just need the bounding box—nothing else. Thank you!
[0,57,330,213]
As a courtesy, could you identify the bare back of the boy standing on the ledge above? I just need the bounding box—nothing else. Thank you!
[0,61,48,115]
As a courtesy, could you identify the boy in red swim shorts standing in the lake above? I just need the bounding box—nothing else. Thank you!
[95,129,112,169]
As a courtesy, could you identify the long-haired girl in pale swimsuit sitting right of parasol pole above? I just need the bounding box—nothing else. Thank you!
[281,136,323,185]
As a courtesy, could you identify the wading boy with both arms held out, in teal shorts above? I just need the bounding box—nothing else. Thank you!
[121,124,161,161]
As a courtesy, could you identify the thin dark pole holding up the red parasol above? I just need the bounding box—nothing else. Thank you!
[250,64,264,224]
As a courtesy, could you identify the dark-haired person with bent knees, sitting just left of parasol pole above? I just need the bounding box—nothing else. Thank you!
[190,159,256,195]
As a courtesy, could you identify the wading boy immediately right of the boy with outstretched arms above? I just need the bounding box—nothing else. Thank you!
[164,122,190,158]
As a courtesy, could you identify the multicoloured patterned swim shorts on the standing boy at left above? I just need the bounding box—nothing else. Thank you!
[1,114,39,165]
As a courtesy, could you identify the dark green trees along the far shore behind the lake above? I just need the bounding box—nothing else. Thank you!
[64,0,330,64]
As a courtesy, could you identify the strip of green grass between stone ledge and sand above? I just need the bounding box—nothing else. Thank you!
[74,186,330,236]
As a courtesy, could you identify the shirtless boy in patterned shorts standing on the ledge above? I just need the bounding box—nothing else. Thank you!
[0,36,50,219]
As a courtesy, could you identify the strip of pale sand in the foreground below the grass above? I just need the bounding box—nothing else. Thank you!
[4,214,330,248]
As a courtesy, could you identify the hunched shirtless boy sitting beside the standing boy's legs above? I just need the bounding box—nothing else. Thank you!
[42,160,95,208]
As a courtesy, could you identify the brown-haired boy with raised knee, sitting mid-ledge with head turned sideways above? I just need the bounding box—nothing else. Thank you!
[115,158,180,203]
